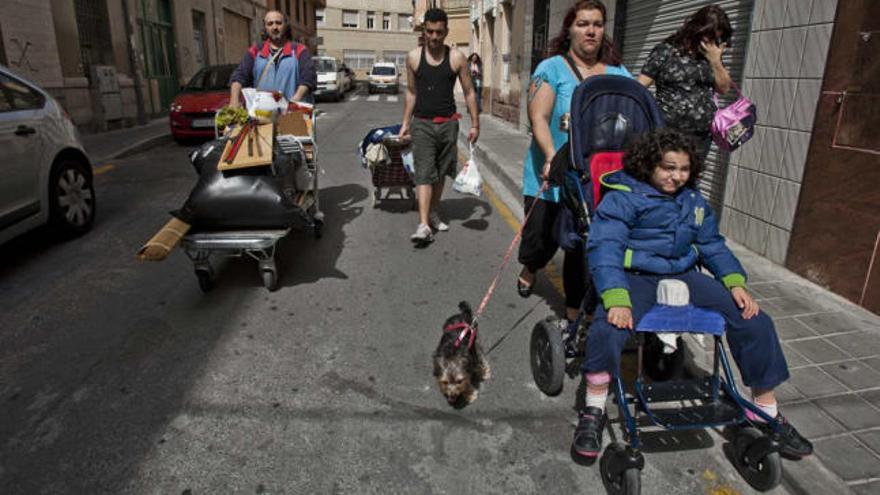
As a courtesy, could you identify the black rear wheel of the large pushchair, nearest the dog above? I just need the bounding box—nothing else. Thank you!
[529,317,565,397]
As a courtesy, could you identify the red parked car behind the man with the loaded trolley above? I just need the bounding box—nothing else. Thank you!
[168,64,237,141]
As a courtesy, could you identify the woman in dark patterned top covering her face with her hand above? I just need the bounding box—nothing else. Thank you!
[638,5,733,159]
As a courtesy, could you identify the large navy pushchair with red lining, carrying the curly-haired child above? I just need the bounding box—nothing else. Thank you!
[530,76,782,494]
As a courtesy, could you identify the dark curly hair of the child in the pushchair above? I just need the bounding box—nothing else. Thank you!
[623,128,703,188]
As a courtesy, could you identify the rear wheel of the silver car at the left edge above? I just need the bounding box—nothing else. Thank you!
[49,159,95,236]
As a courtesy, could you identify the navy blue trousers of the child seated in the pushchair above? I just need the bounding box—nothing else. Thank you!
[581,270,789,389]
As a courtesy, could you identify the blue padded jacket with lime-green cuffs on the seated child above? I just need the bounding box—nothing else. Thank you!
[587,170,745,308]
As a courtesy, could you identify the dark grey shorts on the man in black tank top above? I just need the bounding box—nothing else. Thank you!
[410,117,458,186]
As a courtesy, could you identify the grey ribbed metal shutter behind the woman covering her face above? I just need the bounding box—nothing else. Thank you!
[615,0,754,214]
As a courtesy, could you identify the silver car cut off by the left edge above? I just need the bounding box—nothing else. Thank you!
[0,65,95,242]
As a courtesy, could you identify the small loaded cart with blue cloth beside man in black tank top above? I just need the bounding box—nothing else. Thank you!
[358,124,418,210]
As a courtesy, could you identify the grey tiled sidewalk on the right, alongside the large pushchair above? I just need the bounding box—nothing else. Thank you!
[459,109,880,494]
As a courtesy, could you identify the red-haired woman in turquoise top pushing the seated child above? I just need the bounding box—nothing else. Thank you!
[517,0,632,328]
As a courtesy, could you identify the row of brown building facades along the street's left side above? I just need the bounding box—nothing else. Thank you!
[0,0,324,130]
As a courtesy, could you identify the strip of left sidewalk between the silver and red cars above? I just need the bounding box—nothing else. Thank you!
[80,116,171,166]
